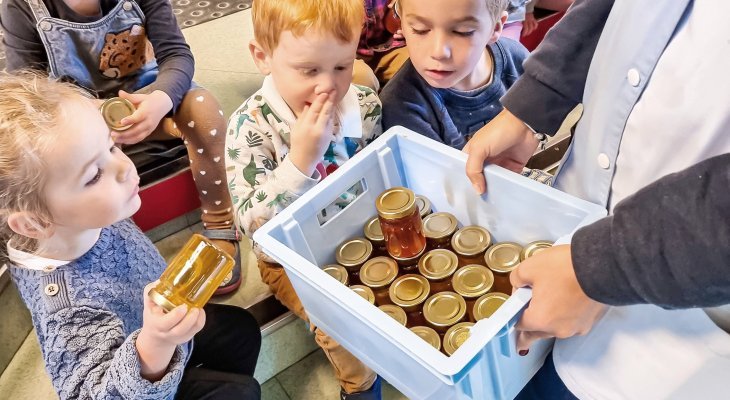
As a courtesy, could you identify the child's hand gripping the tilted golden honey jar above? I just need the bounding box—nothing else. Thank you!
[136,281,205,382]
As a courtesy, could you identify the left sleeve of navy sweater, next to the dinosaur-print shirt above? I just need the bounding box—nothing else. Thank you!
[380,65,446,143]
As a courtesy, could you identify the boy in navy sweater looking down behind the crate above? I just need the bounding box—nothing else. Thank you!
[380,0,529,149]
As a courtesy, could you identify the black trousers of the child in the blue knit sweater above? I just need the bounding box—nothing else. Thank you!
[175,304,261,400]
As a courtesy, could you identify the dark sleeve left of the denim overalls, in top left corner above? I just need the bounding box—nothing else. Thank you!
[0,0,48,72]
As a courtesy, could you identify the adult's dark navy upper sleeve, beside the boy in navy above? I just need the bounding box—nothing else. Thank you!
[502,0,613,135]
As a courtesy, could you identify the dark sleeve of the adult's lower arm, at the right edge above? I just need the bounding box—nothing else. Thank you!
[572,154,730,308]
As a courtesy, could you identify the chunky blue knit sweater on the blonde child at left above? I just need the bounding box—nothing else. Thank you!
[9,220,191,399]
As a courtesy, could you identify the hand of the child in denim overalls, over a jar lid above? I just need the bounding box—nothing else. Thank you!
[114,90,172,144]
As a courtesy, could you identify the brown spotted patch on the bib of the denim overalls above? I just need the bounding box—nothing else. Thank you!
[99,25,155,79]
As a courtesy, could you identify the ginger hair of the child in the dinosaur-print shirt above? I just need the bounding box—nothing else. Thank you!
[251,0,365,54]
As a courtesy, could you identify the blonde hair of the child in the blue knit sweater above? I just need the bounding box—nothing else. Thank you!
[0,71,90,254]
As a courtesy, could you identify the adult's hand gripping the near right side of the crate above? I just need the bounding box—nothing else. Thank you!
[510,245,607,354]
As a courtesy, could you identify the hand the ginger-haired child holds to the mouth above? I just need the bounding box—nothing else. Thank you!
[289,92,335,176]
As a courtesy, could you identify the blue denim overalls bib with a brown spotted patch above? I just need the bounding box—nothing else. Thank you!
[26,0,157,98]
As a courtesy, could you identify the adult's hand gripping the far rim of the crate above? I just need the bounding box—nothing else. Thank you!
[463,109,539,194]
